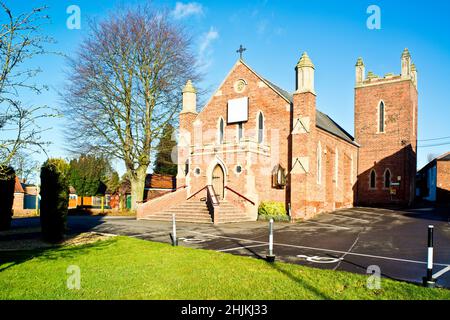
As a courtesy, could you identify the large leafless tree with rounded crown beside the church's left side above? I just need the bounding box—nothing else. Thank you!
[63,6,199,209]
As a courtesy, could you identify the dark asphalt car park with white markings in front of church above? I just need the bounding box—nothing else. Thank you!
[7,208,450,288]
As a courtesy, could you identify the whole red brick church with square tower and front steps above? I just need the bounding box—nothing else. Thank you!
[138,49,418,223]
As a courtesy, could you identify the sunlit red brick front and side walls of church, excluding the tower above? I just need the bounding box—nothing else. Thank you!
[178,60,358,219]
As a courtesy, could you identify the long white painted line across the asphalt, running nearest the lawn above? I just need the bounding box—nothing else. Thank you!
[189,231,450,267]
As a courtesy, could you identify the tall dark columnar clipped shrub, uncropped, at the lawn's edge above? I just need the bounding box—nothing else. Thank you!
[41,159,69,242]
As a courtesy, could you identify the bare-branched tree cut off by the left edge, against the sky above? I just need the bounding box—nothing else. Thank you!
[0,1,53,179]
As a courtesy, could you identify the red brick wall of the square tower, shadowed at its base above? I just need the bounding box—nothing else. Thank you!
[355,78,417,205]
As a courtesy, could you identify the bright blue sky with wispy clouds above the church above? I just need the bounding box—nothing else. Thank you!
[6,0,450,173]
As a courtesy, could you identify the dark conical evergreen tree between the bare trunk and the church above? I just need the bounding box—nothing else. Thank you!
[153,124,177,176]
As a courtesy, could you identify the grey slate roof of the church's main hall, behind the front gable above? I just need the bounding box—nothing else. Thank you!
[240,60,359,146]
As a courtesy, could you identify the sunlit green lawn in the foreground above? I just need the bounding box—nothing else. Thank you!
[0,237,450,299]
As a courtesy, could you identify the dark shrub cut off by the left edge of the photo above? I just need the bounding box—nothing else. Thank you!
[0,166,16,230]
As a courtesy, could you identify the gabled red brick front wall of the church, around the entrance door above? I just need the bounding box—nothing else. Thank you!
[185,60,290,205]
